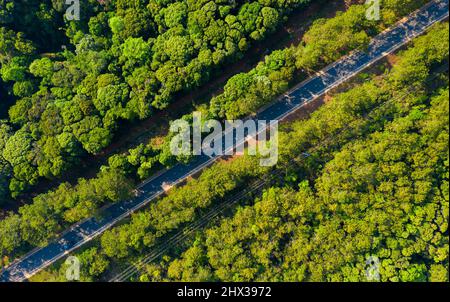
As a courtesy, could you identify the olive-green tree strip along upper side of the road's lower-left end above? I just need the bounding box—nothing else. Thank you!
[0,169,132,255]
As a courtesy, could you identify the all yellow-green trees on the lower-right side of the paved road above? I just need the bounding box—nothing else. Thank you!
[29,21,449,281]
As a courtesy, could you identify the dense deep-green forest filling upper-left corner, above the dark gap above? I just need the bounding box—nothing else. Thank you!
[0,0,309,197]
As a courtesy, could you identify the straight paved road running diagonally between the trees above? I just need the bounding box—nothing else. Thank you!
[0,0,448,282]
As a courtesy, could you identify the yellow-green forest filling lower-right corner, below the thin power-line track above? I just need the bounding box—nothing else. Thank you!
[146,88,449,282]
